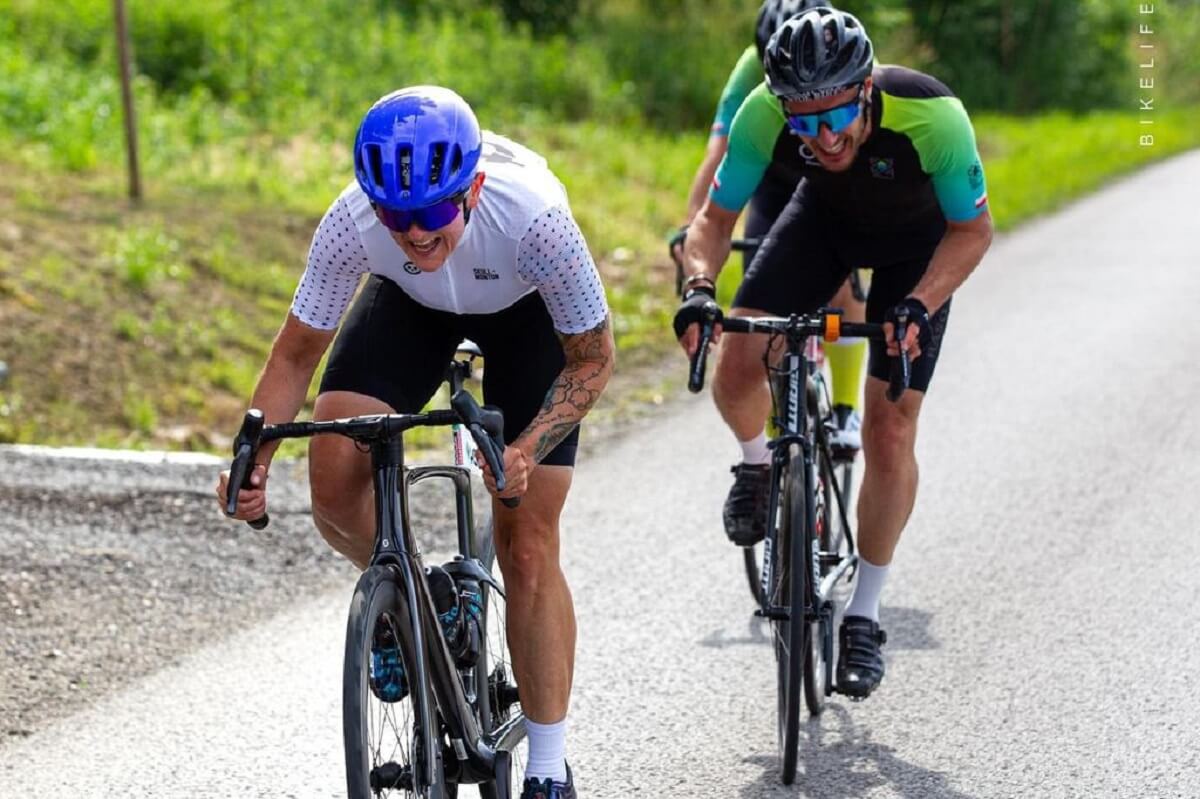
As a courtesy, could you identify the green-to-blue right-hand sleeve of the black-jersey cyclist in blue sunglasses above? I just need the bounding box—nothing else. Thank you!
[883,96,988,222]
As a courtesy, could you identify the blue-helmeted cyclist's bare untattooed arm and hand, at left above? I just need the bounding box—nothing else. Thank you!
[217,313,337,519]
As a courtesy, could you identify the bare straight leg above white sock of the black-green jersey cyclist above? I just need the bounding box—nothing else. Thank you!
[858,377,925,566]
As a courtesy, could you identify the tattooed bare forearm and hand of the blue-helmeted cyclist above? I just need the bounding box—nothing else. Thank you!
[485,317,617,497]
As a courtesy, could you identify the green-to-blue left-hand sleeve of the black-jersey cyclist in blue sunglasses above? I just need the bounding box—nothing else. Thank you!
[708,78,786,211]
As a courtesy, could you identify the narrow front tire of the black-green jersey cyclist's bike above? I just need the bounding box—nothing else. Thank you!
[772,445,808,785]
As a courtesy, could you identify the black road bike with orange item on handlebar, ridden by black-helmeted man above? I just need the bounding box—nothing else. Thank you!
[688,302,911,785]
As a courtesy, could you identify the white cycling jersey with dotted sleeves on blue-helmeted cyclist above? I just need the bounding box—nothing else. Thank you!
[292,131,608,334]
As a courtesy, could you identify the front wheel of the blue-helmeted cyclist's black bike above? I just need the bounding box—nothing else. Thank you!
[342,565,452,799]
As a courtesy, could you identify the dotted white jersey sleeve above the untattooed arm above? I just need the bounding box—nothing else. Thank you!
[292,198,368,330]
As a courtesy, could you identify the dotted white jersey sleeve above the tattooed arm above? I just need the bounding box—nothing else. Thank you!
[517,205,608,335]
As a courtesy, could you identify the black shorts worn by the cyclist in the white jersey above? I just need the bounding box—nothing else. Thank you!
[320,275,580,465]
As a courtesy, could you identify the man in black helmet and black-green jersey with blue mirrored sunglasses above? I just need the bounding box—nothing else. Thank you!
[674,8,992,697]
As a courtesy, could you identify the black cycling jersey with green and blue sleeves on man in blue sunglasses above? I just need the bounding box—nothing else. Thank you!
[709,66,988,229]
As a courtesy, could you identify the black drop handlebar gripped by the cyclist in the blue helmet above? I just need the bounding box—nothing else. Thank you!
[224,390,521,530]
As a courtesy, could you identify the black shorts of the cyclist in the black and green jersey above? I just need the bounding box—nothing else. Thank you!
[733,182,950,391]
